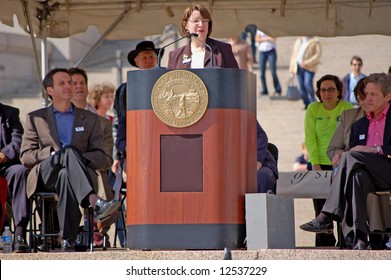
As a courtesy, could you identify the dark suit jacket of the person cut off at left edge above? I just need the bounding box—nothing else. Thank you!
[0,103,23,165]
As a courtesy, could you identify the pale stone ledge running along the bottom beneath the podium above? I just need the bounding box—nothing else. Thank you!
[0,248,391,260]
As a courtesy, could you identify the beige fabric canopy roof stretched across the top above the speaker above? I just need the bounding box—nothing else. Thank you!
[0,0,391,39]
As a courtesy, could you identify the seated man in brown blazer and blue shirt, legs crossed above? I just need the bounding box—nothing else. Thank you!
[20,68,119,251]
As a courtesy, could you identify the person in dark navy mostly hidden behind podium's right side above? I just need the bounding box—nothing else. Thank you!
[257,121,278,193]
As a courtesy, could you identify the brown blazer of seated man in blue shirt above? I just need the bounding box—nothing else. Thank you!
[20,105,107,197]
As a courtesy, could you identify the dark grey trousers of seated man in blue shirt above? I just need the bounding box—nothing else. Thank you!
[37,146,94,239]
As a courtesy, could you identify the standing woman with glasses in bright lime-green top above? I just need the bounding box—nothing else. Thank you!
[304,75,353,246]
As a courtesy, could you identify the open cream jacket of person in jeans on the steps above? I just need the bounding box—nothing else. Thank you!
[289,37,322,74]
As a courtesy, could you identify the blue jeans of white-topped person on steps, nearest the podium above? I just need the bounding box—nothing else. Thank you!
[259,49,281,95]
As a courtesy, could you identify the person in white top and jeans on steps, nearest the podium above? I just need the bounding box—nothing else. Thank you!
[255,30,281,96]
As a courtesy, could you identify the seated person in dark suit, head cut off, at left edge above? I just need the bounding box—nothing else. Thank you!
[0,103,30,253]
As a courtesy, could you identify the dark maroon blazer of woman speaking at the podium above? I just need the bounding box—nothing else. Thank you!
[167,38,239,69]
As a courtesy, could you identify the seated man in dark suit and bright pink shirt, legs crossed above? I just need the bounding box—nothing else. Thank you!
[300,73,391,250]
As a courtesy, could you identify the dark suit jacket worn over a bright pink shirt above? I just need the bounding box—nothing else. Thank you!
[350,106,391,159]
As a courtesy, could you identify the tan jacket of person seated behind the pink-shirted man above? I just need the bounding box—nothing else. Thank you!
[327,107,365,160]
